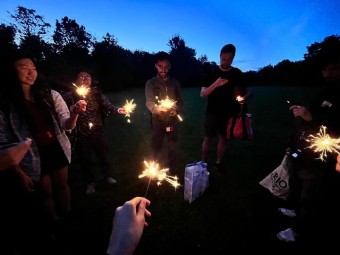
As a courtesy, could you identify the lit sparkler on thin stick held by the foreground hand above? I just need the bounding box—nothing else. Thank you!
[138,161,180,197]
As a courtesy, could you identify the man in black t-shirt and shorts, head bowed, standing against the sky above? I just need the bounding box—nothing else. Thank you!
[200,44,250,171]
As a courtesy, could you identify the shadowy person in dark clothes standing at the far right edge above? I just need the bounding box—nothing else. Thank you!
[277,36,340,247]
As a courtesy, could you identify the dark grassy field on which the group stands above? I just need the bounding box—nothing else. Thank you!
[66,87,315,255]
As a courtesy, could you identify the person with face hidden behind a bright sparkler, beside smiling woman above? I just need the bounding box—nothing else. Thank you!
[63,69,126,194]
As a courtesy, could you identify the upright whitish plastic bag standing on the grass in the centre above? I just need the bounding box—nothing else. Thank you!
[184,161,209,203]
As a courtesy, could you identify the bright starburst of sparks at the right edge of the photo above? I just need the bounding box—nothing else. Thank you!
[306,126,340,161]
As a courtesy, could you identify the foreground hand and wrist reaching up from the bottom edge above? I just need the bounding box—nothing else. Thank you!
[107,197,151,255]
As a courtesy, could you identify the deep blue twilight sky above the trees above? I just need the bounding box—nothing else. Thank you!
[0,0,340,71]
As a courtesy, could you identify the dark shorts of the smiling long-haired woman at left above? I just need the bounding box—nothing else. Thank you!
[39,141,68,176]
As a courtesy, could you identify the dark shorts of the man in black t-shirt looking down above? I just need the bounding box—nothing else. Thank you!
[204,113,229,137]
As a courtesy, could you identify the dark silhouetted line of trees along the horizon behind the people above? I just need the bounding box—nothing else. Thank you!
[0,6,340,92]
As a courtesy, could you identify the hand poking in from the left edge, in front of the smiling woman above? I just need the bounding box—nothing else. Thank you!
[0,138,32,170]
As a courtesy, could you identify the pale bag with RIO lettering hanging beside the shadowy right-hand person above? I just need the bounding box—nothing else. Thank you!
[260,155,289,200]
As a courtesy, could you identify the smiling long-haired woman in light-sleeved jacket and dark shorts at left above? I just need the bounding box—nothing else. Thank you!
[0,51,86,254]
